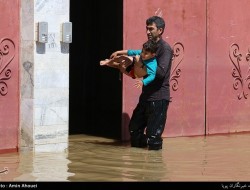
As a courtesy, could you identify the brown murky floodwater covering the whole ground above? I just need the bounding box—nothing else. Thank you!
[0,133,250,182]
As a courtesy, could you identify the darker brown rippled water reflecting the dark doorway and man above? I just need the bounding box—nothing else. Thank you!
[68,137,166,181]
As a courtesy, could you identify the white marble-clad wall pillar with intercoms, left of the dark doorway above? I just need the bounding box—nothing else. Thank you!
[20,0,69,152]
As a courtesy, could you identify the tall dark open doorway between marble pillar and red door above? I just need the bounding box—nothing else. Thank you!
[69,0,123,139]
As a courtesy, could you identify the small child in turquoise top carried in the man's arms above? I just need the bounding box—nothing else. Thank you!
[100,40,157,88]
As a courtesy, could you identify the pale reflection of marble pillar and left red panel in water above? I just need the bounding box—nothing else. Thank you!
[0,152,73,181]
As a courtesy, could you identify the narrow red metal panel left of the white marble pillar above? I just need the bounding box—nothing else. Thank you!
[0,0,19,152]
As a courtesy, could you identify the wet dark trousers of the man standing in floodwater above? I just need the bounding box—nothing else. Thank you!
[129,100,169,149]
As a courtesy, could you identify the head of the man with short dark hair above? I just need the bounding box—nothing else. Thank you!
[146,16,165,41]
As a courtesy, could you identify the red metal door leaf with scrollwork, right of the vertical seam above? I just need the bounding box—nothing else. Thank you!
[206,0,250,134]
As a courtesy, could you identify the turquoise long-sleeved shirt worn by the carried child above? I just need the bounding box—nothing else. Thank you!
[128,49,157,86]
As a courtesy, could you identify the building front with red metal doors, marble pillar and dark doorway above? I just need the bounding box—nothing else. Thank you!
[0,0,250,152]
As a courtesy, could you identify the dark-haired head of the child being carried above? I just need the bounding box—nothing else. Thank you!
[141,40,158,60]
